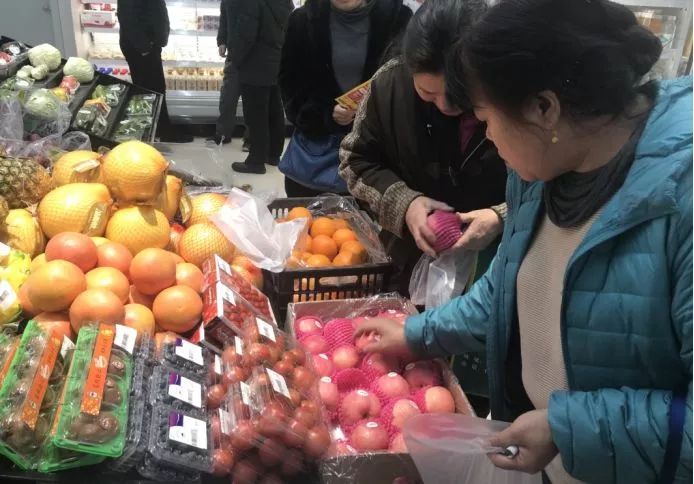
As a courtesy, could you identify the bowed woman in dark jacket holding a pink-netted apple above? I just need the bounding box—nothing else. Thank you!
[340,0,506,288]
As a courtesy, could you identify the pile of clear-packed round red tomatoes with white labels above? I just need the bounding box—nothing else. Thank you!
[208,317,331,483]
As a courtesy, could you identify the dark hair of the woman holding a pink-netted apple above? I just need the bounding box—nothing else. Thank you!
[402,0,487,74]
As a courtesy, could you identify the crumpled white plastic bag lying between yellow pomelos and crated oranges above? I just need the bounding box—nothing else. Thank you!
[210,188,305,272]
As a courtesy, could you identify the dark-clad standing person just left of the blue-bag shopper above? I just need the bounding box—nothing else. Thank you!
[226,0,294,174]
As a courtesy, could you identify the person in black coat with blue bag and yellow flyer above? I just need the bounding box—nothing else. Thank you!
[280,0,412,197]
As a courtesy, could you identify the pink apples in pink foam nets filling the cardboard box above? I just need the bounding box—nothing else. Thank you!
[294,310,462,455]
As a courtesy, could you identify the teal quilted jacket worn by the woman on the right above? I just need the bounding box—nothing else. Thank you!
[406,77,692,484]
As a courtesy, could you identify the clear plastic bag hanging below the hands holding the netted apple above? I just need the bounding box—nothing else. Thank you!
[409,249,477,309]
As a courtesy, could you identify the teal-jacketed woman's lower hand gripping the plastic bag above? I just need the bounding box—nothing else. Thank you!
[489,410,559,474]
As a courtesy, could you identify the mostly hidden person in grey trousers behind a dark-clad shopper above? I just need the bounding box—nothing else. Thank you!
[213,0,250,152]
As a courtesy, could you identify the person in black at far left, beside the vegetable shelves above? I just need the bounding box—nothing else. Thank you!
[118,0,193,143]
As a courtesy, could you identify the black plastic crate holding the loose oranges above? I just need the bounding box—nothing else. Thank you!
[263,198,393,326]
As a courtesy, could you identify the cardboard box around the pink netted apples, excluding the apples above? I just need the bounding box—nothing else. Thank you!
[286,295,475,484]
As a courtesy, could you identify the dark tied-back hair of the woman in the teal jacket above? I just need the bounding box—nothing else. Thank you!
[446,0,662,117]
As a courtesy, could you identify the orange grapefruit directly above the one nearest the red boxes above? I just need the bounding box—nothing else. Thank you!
[130,249,176,296]
